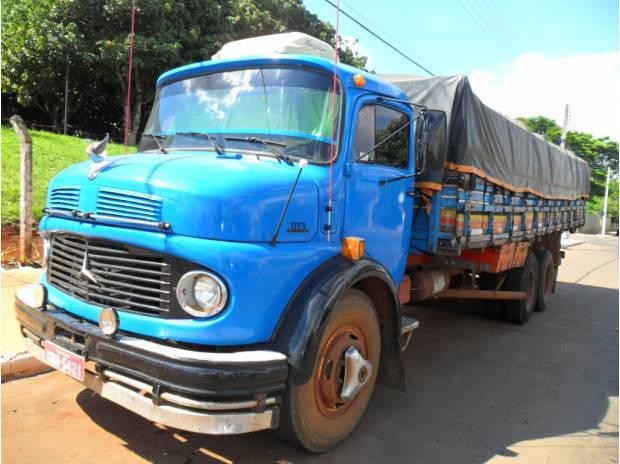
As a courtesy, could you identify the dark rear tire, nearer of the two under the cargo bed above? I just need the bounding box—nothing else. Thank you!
[505,253,539,324]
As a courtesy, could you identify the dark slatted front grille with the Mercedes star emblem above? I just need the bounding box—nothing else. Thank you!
[48,234,172,315]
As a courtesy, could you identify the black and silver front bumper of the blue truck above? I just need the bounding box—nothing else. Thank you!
[15,287,288,434]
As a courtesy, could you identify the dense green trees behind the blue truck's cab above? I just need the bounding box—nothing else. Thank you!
[2,0,366,143]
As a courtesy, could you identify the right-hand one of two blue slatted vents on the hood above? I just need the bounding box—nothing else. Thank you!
[97,188,161,222]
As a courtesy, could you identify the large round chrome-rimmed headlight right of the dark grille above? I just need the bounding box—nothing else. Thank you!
[177,271,228,317]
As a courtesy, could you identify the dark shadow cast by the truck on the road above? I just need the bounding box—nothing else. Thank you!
[77,283,618,464]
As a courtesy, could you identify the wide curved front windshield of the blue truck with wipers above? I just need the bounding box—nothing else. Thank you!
[140,68,341,161]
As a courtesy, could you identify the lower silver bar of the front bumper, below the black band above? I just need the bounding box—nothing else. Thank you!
[24,337,278,435]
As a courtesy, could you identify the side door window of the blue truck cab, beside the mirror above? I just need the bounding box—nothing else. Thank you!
[354,105,410,169]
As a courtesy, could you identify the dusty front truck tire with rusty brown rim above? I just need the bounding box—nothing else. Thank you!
[276,289,381,453]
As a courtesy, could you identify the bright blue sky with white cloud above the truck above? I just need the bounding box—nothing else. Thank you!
[304,0,620,141]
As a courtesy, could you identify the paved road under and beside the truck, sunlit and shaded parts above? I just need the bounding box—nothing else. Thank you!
[2,237,618,464]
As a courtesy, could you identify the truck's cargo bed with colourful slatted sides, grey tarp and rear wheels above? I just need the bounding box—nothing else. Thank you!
[382,75,590,324]
